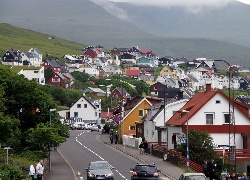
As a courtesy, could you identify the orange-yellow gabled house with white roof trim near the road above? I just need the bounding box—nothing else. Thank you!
[119,97,152,138]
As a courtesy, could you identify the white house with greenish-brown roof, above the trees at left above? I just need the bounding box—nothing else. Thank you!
[11,65,45,85]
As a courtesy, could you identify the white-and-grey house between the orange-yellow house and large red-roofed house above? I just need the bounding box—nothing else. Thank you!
[143,96,188,149]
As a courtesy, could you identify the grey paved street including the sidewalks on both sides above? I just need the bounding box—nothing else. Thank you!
[47,131,182,180]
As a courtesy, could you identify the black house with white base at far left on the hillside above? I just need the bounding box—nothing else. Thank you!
[2,49,23,66]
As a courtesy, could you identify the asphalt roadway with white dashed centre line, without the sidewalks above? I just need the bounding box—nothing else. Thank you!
[60,130,168,180]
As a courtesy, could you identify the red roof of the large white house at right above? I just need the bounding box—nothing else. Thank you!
[166,90,250,126]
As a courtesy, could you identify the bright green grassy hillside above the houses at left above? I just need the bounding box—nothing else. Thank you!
[0,23,86,58]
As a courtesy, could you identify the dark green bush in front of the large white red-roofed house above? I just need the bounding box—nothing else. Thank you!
[176,129,219,165]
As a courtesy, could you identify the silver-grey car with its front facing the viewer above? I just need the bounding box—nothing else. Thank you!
[85,161,114,180]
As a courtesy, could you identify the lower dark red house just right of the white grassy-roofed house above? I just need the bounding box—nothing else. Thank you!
[46,72,73,89]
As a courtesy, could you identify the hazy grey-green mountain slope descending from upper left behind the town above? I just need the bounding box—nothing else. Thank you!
[0,0,250,66]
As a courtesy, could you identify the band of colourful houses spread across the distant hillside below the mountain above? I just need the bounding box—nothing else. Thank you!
[2,45,250,91]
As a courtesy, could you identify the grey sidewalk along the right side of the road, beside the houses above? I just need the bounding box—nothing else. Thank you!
[99,134,184,180]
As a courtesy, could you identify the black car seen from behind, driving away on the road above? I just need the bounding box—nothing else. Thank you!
[130,164,160,180]
